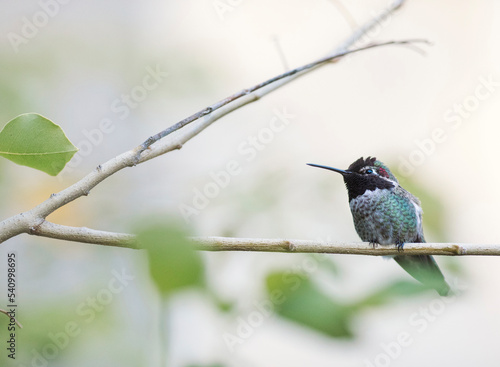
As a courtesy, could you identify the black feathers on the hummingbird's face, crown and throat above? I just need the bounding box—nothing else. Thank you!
[342,157,394,201]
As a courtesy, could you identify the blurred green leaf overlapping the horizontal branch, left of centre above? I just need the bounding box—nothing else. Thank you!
[138,222,204,295]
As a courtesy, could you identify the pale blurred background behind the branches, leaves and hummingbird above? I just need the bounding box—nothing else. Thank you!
[0,0,500,367]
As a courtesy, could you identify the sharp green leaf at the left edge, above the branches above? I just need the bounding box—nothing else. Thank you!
[0,113,78,176]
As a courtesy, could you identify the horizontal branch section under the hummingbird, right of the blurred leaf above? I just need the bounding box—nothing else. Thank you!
[193,237,500,256]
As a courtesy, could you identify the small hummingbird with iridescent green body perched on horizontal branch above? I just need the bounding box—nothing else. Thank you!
[308,157,450,296]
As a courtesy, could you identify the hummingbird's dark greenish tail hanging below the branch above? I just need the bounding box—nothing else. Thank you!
[394,255,450,296]
